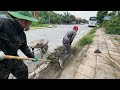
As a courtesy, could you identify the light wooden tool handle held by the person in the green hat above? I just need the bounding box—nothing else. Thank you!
[4,55,50,62]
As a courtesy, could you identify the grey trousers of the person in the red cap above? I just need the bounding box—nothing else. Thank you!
[61,44,72,61]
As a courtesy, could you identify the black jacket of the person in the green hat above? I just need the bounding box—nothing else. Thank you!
[0,18,34,58]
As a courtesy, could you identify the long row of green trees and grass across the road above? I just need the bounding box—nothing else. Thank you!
[0,11,88,28]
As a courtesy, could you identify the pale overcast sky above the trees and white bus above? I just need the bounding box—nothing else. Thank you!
[54,11,97,20]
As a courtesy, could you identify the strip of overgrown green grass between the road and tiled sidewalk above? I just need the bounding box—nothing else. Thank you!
[73,27,98,53]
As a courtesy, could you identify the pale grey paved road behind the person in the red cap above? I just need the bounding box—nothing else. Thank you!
[8,24,91,78]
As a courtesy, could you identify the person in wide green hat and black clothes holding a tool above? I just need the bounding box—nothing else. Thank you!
[0,11,38,79]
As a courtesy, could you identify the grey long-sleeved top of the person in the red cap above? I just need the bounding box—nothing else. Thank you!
[62,30,76,45]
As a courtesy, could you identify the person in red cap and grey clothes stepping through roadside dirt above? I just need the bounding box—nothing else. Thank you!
[59,26,78,68]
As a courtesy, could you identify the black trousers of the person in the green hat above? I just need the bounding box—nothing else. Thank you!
[0,59,28,79]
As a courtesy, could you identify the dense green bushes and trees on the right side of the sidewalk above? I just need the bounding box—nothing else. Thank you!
[97,11,120,35]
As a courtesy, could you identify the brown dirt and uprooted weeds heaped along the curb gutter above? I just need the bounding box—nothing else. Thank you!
[30,46,77,79]
